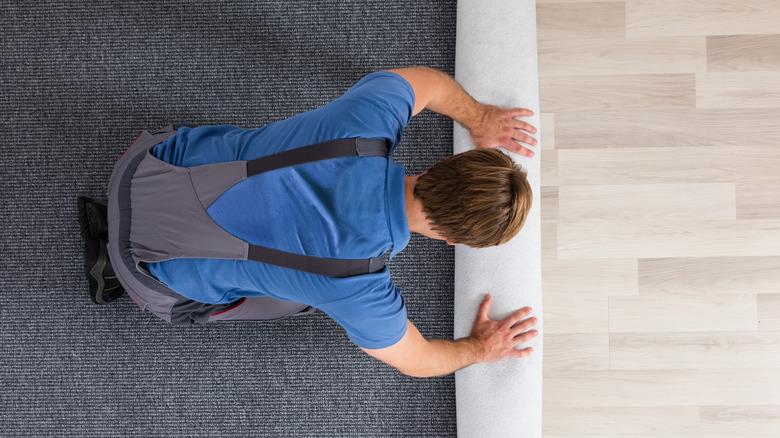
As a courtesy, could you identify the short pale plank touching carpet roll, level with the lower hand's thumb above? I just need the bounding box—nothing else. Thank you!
[543,294,608,334]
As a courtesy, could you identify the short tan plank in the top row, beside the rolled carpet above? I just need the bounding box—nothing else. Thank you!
[536,1,626,40]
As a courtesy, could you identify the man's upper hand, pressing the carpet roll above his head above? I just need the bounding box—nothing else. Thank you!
[468,105,537,157]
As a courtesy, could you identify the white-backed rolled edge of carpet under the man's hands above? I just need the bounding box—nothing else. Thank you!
[453,0,543,438]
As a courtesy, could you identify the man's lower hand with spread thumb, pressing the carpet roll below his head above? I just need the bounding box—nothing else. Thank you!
[469,295,539,362]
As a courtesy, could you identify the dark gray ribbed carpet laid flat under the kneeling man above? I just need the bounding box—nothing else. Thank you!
[0,0,455,437]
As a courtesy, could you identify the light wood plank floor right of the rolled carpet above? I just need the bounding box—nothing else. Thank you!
[537,0,780,438]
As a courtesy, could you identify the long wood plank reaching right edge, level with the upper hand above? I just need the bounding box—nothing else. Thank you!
[555,108,780,150]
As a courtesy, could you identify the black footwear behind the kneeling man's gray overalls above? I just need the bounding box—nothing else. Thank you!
[78,196,125,304]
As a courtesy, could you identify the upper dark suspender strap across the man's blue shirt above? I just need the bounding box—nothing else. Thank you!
[246,137,388,178]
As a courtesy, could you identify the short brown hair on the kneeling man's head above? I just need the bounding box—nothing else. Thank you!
[414,149,533,248]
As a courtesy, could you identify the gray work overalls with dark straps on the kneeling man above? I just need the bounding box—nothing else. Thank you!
[108,125,388,324]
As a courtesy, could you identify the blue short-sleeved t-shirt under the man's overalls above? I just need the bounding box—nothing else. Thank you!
[147,72,414,349]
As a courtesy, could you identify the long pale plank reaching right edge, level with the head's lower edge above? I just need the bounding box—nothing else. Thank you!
[557,220,780,260]
